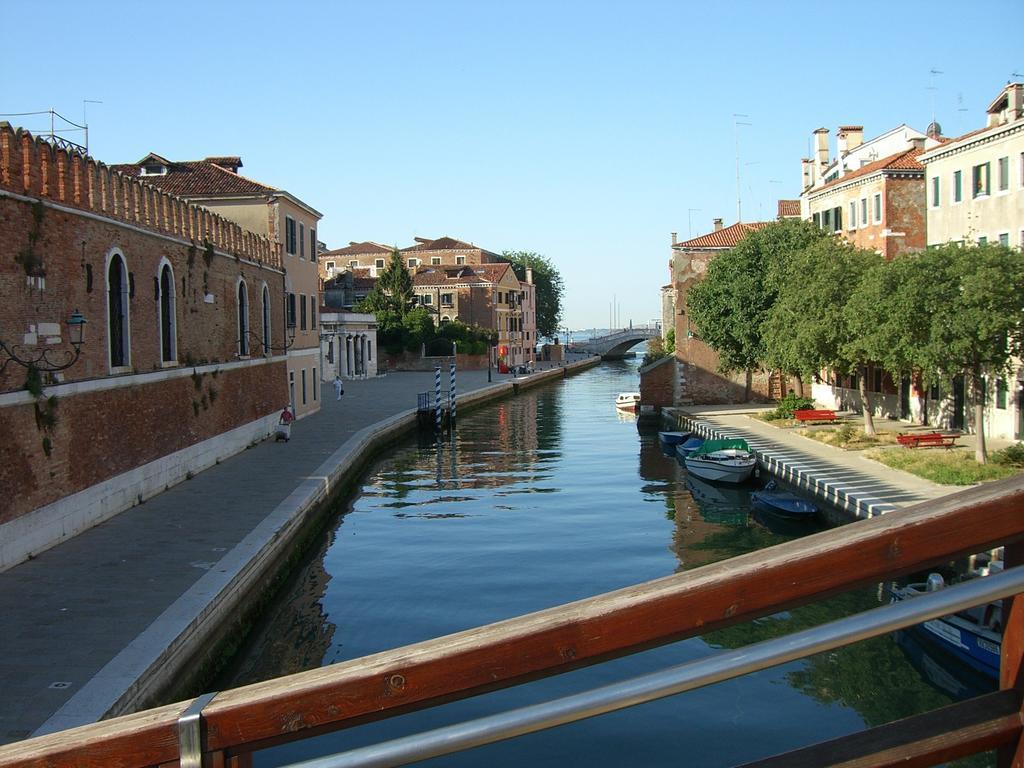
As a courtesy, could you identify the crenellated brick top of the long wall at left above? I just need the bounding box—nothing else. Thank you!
[0,122,283,269]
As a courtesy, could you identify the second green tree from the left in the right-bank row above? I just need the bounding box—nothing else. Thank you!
[764,238,882,435]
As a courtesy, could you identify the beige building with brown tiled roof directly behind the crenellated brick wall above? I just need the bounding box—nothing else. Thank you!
[114,153,323,419]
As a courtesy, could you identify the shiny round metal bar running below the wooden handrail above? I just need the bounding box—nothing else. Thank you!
[286,566,1024,768]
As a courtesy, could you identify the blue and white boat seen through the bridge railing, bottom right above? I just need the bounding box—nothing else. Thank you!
[891,573,1002,679]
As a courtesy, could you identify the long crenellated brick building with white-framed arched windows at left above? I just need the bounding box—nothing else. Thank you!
[0,123,287,569]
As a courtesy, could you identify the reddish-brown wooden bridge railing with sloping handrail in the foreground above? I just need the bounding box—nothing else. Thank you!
[0,476,1024,768]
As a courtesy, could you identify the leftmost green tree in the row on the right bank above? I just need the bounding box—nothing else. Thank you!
[686,219,827,397]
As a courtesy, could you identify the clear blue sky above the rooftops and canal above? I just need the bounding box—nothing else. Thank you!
[0,0,1024,329]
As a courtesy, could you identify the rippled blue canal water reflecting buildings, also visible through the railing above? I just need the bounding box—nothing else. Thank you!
[218,360,989,768]
